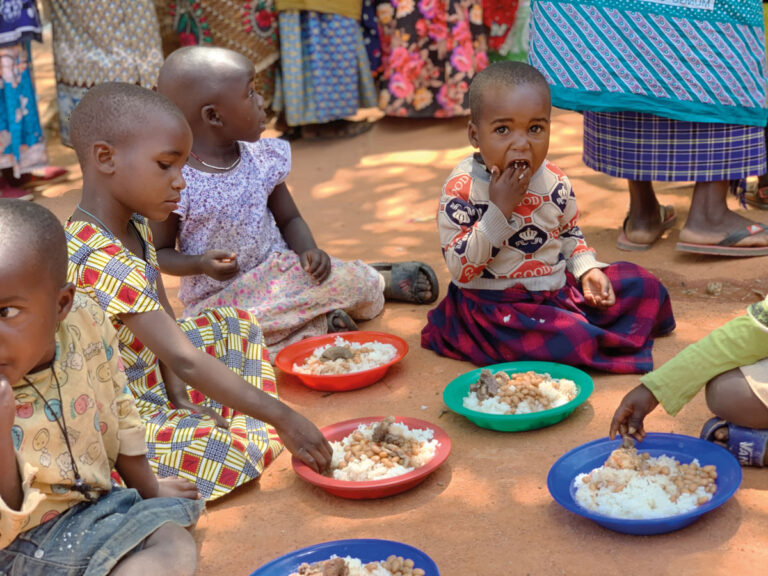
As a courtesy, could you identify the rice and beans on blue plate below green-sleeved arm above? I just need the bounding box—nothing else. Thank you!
[574,448,717,519]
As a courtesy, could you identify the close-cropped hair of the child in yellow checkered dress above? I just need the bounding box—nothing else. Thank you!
[69,82,189,165]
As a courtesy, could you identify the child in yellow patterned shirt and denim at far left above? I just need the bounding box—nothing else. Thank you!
[0,199,204,576]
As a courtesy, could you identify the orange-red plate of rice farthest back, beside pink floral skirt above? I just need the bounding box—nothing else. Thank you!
[275,330,408,392]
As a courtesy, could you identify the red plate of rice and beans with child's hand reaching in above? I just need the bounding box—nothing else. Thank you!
[292,416,451,499]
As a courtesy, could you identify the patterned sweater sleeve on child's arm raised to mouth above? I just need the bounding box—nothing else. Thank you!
[437,172,515,283]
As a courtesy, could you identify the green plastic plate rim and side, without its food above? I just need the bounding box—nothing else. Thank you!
[443,361,595,432]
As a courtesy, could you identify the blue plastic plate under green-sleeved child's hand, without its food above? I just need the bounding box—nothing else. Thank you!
[547,433,741,535]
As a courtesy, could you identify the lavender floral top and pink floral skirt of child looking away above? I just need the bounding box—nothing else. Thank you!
[176,138,384,354]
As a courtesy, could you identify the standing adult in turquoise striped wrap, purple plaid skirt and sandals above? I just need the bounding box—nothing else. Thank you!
[530,0,768,256]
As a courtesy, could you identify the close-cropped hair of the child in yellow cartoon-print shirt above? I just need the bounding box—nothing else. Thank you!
[0,198,67,288]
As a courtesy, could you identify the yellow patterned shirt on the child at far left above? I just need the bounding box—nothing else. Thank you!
[0,294,147,548]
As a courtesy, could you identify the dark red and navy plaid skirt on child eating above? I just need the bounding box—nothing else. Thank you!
[421,262,675,373]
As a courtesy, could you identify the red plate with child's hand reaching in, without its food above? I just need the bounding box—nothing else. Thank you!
[292,416,451,500]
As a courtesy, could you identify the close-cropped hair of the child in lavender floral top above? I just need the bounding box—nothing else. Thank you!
[157,46,254,124]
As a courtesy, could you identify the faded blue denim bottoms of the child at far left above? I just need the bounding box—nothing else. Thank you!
[0,488,205,576]
